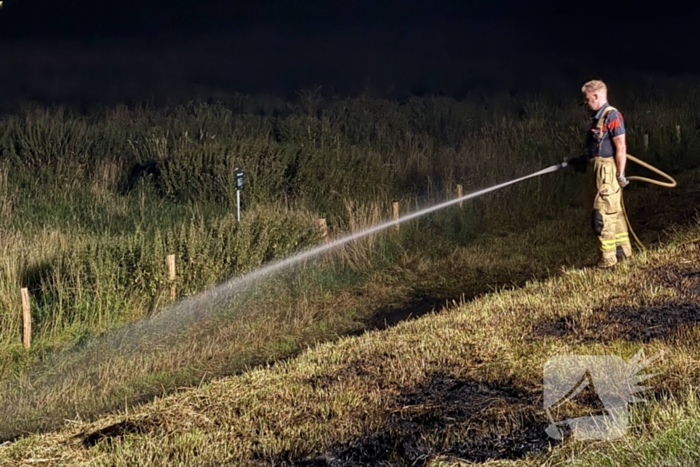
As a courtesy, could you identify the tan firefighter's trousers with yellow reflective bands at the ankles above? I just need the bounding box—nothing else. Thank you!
[584,157,632,267]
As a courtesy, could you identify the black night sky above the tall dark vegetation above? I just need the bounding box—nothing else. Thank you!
[0,0,700,102]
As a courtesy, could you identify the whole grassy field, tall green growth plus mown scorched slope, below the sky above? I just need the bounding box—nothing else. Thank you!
[0,85,700,465]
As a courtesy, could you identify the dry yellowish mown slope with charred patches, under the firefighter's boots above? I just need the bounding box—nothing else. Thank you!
[1,209,700,465]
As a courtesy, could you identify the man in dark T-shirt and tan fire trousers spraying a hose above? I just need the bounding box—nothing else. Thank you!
[574,80,632,268]
